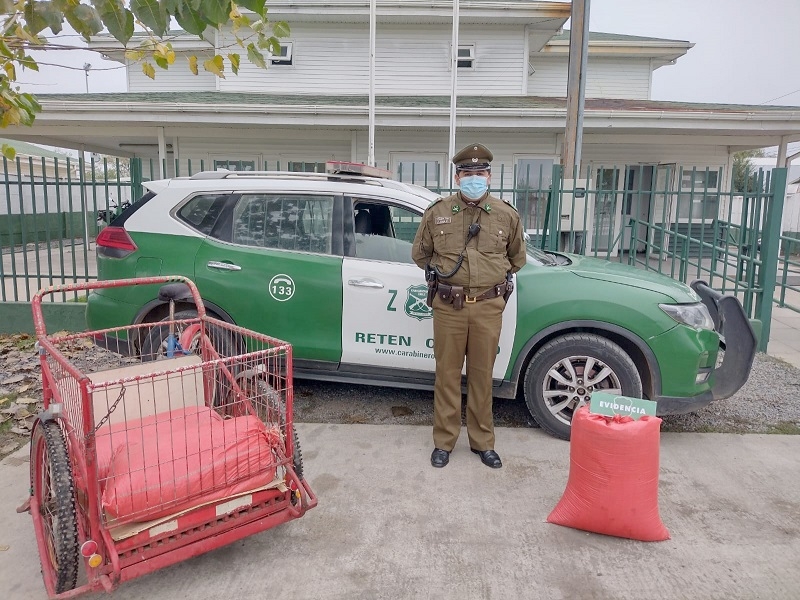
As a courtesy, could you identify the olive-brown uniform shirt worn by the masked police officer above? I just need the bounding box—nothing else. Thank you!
[411,193,525,296]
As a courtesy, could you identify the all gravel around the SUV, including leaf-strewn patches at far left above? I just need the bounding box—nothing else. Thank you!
[0,334,800,458]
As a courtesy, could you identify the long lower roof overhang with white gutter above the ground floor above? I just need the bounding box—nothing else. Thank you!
[4,92,800,156]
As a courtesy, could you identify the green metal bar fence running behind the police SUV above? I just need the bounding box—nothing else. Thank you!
[0,158,788,350]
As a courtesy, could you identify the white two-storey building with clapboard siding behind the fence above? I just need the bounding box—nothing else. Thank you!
[1,0,800,251]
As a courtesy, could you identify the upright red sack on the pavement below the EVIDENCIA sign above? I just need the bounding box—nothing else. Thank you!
[547,406,669,542]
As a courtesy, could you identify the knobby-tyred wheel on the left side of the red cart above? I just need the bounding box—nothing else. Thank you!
[31,421,80,594]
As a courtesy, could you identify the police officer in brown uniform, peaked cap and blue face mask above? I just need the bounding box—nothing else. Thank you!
[412,144,525,469]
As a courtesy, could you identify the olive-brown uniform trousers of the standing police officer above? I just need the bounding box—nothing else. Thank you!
[433,296,506,452]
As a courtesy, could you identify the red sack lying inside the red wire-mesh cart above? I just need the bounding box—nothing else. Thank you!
[96,406,282,521]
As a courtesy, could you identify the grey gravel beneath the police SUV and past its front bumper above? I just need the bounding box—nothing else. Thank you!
[294,354,800,434]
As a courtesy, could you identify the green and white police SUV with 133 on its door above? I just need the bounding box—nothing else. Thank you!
[87,163,756,439]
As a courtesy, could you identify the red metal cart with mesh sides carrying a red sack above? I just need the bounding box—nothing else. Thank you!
[22,277,317,598]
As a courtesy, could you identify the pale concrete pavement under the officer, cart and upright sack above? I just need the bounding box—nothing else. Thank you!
[0,424,800,600]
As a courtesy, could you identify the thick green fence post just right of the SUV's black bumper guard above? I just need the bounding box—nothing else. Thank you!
[753,168,788,352]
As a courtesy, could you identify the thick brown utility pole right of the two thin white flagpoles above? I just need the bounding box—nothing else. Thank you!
[561,0,590,179]
